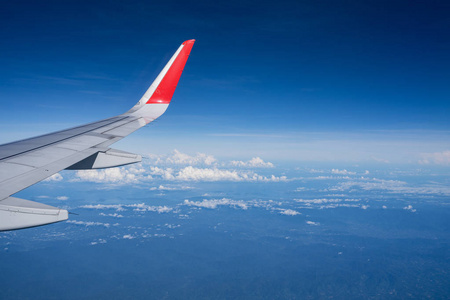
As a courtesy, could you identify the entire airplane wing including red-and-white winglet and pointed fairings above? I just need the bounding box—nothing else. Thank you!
[0,40,195,231]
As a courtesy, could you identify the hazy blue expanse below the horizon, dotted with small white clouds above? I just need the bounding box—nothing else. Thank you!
[0,163,450,299]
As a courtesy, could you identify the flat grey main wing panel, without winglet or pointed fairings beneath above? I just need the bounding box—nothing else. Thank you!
[0,116,146,203]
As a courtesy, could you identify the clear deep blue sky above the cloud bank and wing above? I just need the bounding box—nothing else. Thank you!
[0,1,450,162]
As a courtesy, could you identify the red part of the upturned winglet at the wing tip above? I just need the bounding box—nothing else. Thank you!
[147,40,195,104]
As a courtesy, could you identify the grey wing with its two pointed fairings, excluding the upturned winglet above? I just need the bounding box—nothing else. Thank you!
[0,115,147,231]
